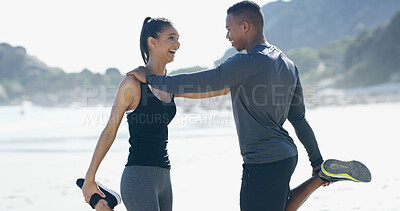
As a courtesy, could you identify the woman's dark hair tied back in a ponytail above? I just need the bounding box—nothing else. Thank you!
[140,17,173,64]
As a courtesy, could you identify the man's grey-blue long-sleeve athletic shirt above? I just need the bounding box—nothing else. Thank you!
[146,44,322,167]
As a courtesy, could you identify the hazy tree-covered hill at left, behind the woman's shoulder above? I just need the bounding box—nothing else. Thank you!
[0,43,122,105]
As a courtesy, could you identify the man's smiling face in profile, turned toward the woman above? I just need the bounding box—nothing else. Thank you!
[226,14,245,51]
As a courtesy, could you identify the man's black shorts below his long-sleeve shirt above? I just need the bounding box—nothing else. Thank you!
[240,155,297,211]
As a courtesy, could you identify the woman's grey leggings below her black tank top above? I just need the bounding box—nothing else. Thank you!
[121,165,172,211]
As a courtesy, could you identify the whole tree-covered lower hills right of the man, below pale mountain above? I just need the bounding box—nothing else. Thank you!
[286,10,400,88]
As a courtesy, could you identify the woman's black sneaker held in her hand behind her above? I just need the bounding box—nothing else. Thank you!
[76,178,121,209]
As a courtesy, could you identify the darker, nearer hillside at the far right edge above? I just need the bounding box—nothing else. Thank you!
[339,11,400,87]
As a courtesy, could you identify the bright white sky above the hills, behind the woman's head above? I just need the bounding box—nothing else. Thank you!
[0,0,275,73]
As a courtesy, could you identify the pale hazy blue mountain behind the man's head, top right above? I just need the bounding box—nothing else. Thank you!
[215,0,400,65]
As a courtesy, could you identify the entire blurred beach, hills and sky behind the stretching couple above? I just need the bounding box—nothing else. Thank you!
[0,0,400,210]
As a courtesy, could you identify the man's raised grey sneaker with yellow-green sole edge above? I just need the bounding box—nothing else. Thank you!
[318,159,371,182]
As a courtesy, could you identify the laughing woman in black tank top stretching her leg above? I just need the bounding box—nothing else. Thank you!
[82,17,230,211]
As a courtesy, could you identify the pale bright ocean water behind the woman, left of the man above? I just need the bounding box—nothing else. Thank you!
[0,106,236,152]
